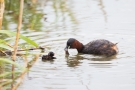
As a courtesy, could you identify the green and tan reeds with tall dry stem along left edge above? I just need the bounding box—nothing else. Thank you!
[0,0,38,90]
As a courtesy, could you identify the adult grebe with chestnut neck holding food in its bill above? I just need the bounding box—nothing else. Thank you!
[65,38,118,56]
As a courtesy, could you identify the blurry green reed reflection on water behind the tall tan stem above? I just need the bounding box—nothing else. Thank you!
[3,0,44,31]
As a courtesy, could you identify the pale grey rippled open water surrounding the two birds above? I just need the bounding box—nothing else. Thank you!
[18,0,135,90]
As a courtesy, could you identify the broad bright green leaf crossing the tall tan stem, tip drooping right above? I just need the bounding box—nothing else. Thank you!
[0,30,38,47]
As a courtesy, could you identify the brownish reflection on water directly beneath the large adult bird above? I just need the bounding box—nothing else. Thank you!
[65,54,117,67]
